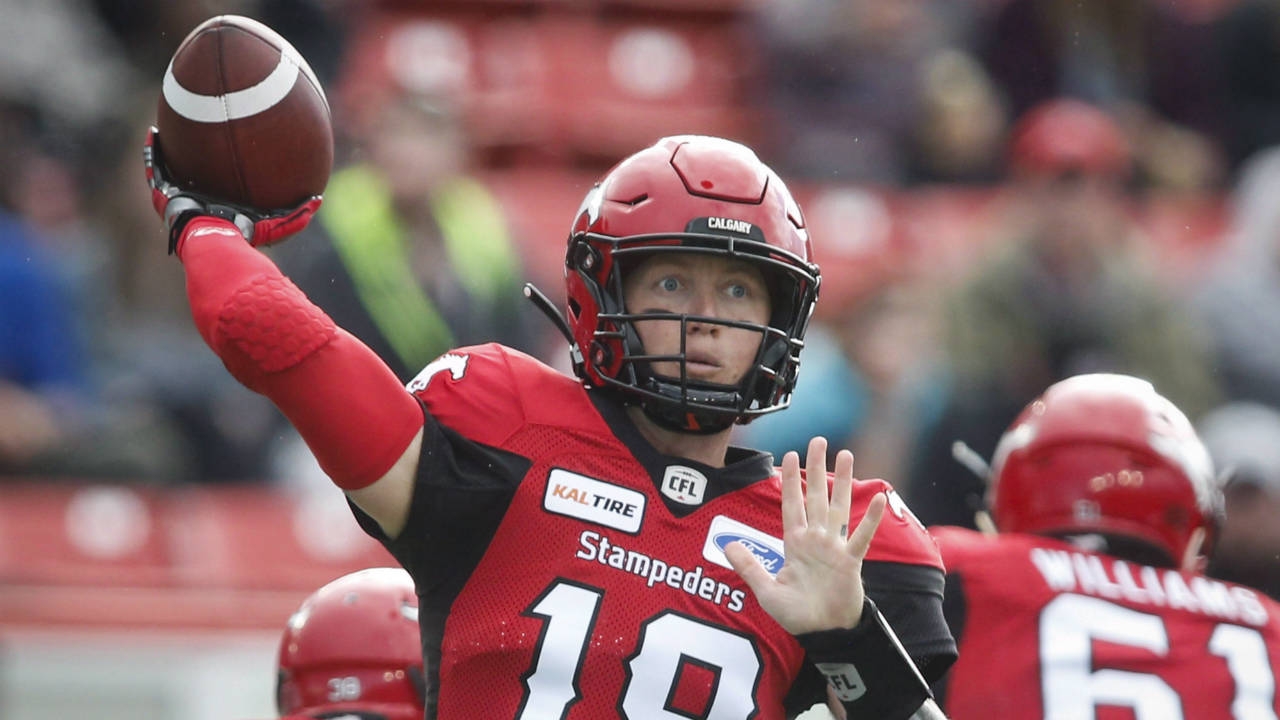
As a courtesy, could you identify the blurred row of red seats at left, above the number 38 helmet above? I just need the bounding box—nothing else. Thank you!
[0,480,396,630]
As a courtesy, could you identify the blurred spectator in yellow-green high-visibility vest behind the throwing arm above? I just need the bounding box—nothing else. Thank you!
[278,94,538,382]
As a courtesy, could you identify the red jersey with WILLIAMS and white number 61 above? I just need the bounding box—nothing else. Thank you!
[932,520,1280,720]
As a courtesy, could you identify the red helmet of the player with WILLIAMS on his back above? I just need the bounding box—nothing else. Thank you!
[989,374,1221,565]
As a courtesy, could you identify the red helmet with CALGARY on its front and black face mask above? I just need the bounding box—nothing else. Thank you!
[564,136,819,432]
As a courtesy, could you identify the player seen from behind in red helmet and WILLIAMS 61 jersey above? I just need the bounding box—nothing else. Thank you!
[933,374,1280,720]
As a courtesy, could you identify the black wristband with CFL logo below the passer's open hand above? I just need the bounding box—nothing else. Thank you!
[796,597,933,720]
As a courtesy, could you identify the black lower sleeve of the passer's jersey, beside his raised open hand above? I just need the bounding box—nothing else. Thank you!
[863,561,956,683]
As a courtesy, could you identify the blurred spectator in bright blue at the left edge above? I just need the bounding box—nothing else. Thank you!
[0,94,192,480]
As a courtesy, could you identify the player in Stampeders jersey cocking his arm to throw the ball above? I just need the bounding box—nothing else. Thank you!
[146,135,955,720]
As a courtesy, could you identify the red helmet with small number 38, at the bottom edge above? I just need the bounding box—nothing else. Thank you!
[275,568,424,720]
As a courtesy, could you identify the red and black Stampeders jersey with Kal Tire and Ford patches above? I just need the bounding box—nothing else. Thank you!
[356,345,955,720]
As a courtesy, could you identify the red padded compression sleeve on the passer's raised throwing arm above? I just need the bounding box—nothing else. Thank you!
[178,218,422,489]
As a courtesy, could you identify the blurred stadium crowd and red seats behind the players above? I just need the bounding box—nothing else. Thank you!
[0,0,1280,720]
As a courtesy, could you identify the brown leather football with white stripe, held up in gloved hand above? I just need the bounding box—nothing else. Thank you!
[156,15,333,210]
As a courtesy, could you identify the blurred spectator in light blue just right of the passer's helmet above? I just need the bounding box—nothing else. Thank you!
[740,279,948,492]
